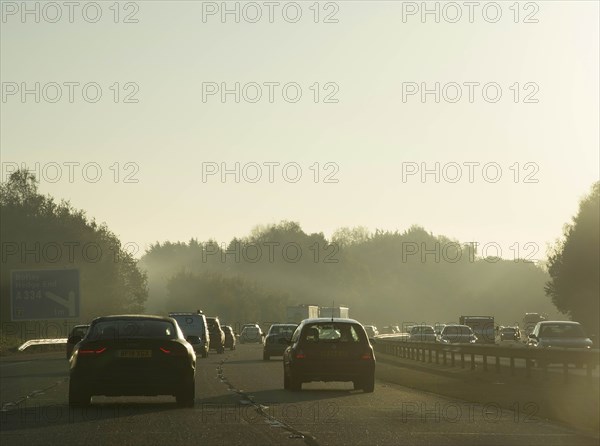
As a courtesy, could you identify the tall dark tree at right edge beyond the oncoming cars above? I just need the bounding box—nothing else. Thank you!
[545,182,600,334]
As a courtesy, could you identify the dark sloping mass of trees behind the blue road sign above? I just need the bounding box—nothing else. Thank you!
[0,170,148,337]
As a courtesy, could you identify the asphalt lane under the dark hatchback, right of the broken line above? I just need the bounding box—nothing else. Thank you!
[218,345,598,445]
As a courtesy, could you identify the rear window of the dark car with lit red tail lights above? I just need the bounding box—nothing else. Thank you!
[88,320,177,340]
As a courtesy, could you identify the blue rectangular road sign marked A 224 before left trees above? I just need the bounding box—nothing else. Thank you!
[10,269,80,321]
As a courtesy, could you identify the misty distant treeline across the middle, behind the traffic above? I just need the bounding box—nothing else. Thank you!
[140,222,556,324]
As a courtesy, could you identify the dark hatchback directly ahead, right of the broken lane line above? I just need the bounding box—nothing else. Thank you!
[281,318,375,392]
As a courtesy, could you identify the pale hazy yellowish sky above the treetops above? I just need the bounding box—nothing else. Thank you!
[0,1,600,258]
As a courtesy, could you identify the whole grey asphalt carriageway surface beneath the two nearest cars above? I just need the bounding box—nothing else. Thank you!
[0,344,599,446]
